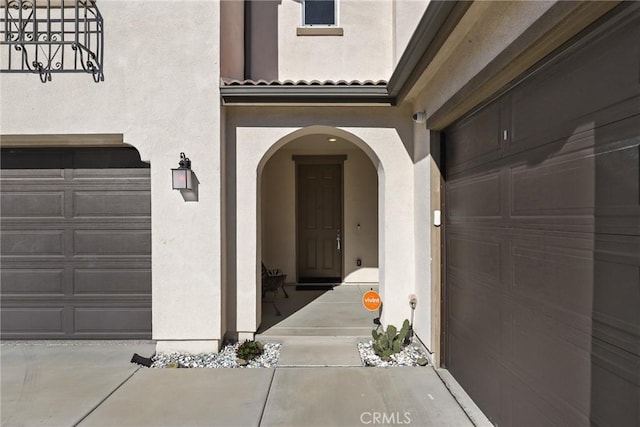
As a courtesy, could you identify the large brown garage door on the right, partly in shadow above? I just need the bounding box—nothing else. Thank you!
[444,8,640,427]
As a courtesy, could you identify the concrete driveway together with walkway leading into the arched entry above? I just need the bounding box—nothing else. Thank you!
[0,285,490,427]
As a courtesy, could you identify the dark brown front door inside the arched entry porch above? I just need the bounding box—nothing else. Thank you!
[297,164,342,282]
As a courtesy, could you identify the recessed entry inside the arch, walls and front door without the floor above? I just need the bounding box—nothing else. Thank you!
[259,134,379,283]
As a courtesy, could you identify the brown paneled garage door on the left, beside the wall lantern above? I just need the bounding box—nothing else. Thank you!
[0,149,151,339]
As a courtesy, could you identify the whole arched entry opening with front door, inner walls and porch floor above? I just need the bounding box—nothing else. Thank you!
[259,133,379,334]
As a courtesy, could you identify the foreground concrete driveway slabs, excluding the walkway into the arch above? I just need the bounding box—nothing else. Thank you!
[0,342,484,427]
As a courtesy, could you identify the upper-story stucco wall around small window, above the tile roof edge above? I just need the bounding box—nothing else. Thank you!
[250,0,393,80]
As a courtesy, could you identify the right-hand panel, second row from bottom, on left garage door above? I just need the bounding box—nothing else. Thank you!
[73,267,151,295]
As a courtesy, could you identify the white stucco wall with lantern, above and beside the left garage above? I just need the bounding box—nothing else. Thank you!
[0,0,224,352]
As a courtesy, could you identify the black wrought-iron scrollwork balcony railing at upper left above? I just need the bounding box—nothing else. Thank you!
[0,0,104,83]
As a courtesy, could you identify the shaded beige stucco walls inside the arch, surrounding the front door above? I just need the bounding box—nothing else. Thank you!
[261,139,378,283]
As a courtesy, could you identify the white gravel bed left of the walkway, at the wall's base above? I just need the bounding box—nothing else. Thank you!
[151,343,281,368]
